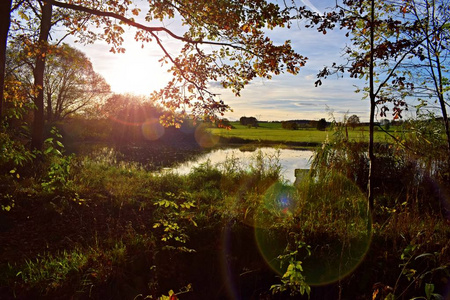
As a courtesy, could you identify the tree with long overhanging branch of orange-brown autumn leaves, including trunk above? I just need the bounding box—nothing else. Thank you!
[4,0,306,149]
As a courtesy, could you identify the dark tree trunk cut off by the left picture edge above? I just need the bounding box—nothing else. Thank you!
[0,0,12,120]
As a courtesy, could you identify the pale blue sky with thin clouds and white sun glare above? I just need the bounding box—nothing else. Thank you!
[60,0,408,121]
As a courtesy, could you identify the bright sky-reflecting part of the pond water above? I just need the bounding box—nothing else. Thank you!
[171,147,313,183]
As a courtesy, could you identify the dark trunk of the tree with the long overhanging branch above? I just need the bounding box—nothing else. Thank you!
[31,1,52,150]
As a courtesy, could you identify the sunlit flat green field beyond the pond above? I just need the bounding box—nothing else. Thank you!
[210,122,395,144]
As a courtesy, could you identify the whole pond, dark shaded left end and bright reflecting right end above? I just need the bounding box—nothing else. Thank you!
[74,144,313,183]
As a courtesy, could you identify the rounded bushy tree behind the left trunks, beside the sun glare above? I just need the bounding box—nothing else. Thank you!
[8,44,110,122]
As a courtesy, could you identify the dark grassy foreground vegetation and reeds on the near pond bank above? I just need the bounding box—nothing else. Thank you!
[0,114,450,299]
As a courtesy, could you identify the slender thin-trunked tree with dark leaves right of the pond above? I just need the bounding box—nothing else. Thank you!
[316,0,424,216]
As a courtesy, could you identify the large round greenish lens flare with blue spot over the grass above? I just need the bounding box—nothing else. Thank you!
[255,174,371,285]
